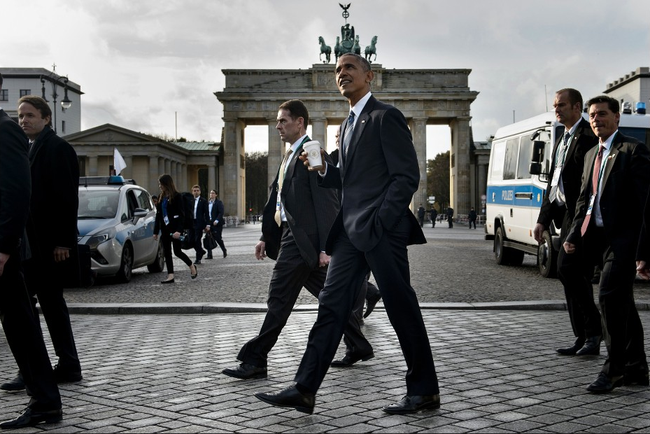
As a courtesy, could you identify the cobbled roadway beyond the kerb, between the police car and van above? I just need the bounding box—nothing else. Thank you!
[58,224,650,304]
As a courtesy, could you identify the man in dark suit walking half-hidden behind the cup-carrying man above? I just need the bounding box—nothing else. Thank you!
[223,100,374,379]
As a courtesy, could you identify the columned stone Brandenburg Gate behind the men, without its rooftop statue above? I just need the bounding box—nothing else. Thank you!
[215,64,478,216]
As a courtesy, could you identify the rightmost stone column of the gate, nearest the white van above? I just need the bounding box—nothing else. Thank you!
[449,117,471,215]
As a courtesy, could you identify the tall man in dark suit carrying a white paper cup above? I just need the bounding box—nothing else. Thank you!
[255,54,440,414]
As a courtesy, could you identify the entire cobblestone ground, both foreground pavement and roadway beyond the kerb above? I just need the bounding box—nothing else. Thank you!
[0,225,650,433]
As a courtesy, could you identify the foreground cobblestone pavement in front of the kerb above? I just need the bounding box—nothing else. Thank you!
[0,310,650,433]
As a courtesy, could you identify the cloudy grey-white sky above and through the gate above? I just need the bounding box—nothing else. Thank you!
[0,0,650,158]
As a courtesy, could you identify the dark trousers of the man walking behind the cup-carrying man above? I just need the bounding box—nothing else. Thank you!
[237,229,372,367]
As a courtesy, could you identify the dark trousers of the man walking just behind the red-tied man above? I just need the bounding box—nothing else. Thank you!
[557,212,603,340]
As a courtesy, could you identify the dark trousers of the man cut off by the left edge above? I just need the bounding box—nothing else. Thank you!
[0,253,61,411]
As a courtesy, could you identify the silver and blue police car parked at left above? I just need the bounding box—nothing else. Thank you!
[77,176,165,282]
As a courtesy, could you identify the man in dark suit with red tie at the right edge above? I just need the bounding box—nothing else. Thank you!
[564,96,650,393]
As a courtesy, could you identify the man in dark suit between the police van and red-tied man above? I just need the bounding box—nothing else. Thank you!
[533,88,602,356]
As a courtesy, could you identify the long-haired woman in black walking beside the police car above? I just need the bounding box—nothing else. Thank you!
[153,174,199,284]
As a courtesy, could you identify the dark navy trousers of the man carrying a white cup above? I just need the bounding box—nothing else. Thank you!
[295,218,439,395]
